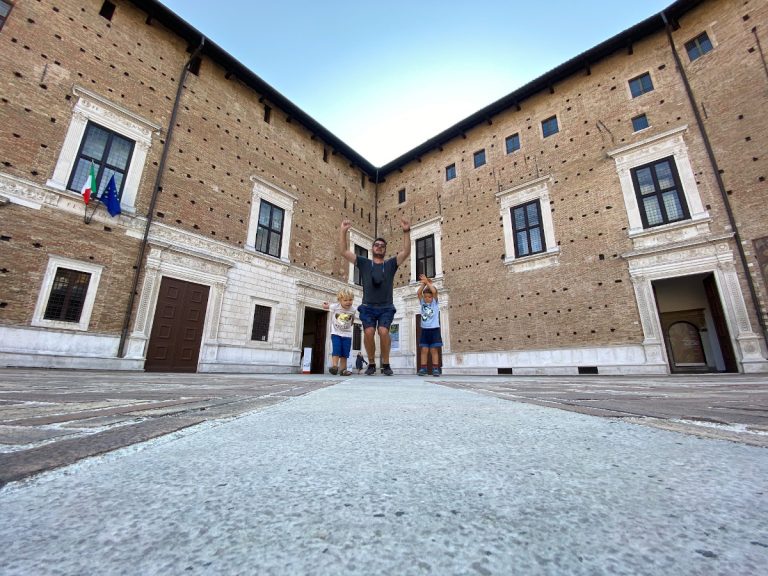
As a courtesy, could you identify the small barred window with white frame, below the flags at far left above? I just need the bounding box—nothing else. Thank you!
[32,256,102,330]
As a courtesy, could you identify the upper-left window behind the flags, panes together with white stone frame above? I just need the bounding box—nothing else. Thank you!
[46,86,160,214]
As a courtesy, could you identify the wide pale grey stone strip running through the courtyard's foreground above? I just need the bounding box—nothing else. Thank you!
[0,377,768,576]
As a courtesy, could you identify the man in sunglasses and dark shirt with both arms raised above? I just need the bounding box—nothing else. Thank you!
[339,218,411,376]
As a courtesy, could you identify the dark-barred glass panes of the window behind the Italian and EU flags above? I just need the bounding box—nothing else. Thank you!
[67,122,134,198]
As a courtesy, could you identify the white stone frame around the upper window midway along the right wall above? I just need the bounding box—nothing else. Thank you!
[496,175,560,272]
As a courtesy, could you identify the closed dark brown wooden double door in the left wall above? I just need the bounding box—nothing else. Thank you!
[144,276,208,372]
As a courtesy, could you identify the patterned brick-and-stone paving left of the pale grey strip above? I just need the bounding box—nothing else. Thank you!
[0,369,333,486]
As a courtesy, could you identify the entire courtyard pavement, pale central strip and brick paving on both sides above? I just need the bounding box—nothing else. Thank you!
[0,369,768,576]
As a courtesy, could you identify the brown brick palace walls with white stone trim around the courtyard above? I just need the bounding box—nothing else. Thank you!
[0,0,768,374]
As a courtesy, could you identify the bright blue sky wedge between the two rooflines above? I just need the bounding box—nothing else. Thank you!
[161,0,673,166]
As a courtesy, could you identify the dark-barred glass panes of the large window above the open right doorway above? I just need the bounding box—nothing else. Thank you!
[631,156,690,228]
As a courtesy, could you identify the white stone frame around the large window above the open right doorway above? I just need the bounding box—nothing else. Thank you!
[608,125,709,238]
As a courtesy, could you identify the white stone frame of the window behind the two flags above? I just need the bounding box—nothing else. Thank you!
[46,86,160,214]
